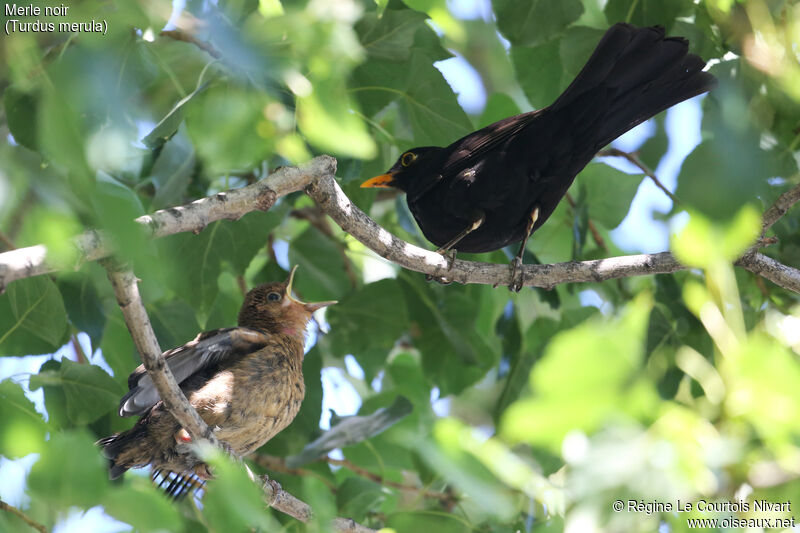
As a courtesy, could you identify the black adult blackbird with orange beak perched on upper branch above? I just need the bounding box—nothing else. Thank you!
[361,24,716,291]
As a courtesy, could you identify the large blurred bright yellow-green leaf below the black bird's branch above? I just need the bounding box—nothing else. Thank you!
[502,295,657,450]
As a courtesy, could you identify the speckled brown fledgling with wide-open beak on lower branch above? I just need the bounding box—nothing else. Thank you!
[98,266,336,495]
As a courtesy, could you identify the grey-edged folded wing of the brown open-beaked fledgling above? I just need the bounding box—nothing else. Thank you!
[119,328,270,416]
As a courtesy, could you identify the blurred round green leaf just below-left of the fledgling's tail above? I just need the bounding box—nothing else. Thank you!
[28,431,108,510]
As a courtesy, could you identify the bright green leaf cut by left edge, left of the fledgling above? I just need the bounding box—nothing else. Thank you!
[0,379,47,459]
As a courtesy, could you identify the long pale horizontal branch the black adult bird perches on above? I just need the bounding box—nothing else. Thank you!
[0,156,800,292]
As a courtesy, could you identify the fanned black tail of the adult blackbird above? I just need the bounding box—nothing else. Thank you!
[550,23,717,150]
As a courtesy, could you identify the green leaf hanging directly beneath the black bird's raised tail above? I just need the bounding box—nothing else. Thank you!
[575,163,644,229]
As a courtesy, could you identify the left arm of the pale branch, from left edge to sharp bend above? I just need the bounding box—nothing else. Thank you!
[0,155,336,292]
